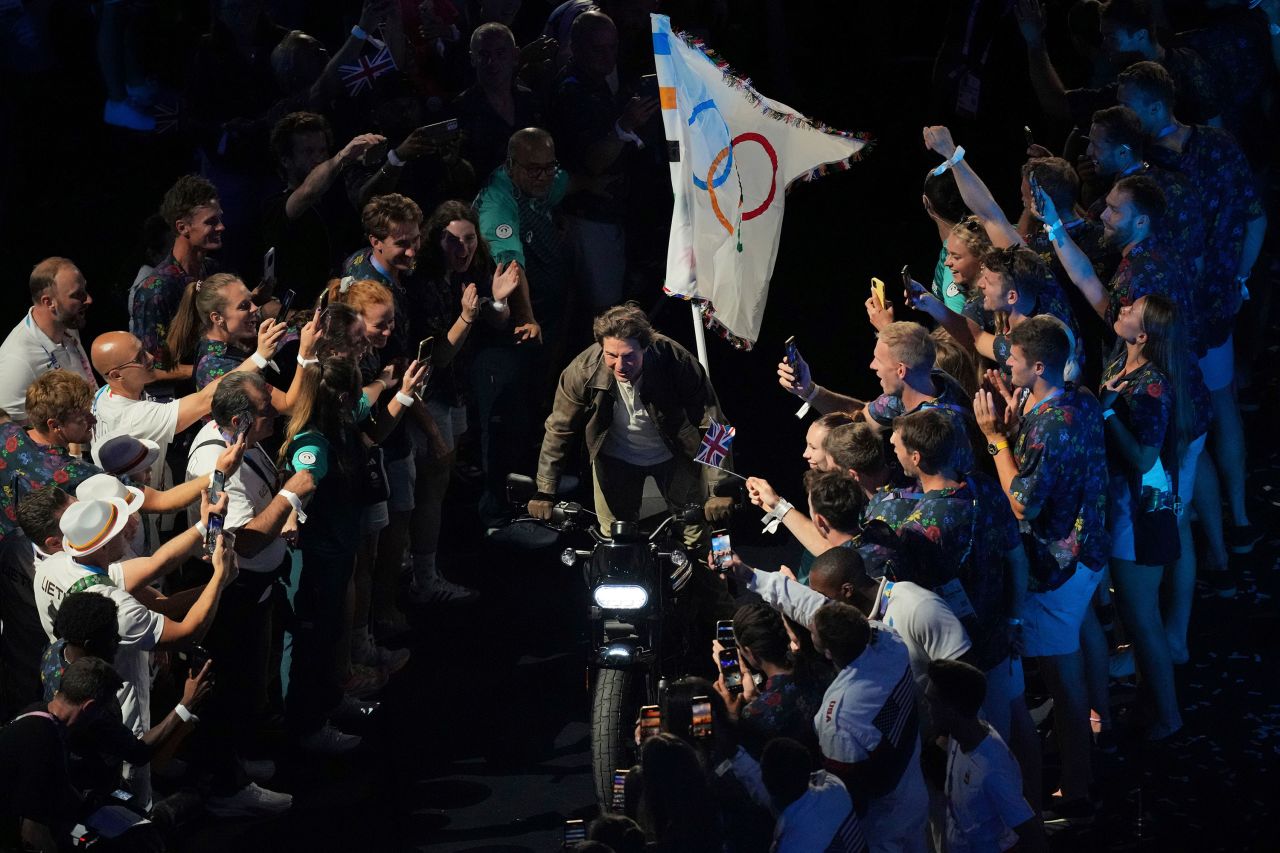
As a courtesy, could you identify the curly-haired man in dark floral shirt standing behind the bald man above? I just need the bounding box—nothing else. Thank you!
[129,174,227,383]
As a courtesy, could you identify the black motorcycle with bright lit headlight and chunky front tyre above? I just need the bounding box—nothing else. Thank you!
[503,474,703,811]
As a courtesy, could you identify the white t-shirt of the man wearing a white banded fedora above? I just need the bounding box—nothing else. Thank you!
[35,551,164,736]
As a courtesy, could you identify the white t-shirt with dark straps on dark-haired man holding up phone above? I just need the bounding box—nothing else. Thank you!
[186,421,288,571]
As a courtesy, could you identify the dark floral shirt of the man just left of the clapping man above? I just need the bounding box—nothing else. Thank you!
[897,473,1021,671]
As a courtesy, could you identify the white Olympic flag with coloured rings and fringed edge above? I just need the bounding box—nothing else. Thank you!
[650,15,867,350]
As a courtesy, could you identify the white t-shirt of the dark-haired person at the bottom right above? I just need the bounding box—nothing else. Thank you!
[945,724,1034,853]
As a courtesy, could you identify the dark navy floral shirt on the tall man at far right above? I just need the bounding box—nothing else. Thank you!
[1148,127,1263,348]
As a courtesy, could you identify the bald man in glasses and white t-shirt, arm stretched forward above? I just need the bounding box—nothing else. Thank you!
[90,333,270,488]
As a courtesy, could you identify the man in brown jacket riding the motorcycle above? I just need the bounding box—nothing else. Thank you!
[529,304,733,547]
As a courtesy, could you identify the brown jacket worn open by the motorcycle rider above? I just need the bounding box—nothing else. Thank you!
[538,334,732,494]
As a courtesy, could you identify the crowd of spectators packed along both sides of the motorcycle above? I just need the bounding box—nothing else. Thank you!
[0,0,1280,853]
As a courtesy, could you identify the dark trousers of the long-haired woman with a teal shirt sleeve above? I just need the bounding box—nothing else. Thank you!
[284,545,358,735]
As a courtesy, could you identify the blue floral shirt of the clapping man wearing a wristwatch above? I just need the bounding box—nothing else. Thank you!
[1009,383,1110,592]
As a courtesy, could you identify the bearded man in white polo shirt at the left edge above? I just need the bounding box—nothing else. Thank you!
[0,257,97,423]
